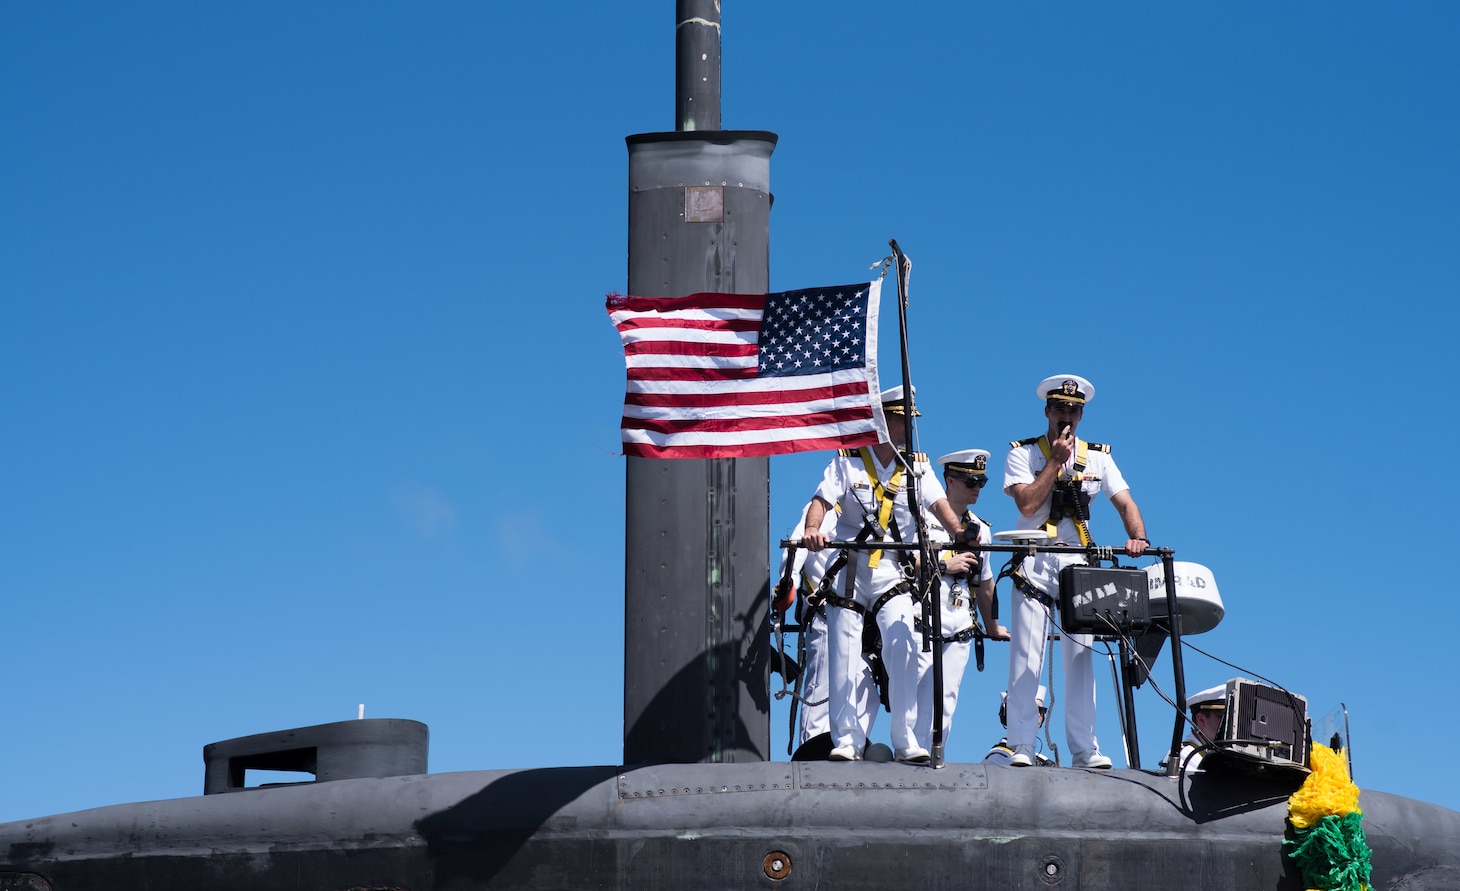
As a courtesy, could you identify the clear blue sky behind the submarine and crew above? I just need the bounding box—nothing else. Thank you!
[0,0,1460,821]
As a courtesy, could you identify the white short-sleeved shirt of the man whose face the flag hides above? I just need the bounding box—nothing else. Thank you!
[816,448,948,595]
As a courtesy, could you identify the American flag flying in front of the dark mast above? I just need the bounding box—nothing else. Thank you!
[607,280,888,459]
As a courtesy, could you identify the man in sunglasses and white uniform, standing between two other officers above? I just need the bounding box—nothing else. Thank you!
[914,448,1009,748]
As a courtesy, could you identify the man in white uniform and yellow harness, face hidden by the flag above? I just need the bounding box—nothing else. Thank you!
[802,387,964,764]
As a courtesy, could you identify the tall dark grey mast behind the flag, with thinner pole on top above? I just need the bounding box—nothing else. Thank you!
[623,0,775,764]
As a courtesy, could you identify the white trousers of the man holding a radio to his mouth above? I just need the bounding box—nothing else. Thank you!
[1007,558,1096,755]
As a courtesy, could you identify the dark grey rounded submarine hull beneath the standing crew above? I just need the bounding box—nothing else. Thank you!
[0,762,1460,891]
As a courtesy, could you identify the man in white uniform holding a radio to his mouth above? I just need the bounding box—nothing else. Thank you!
[1003,374,1150,768]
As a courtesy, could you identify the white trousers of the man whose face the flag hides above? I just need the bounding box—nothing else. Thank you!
[826,594,917,752]
